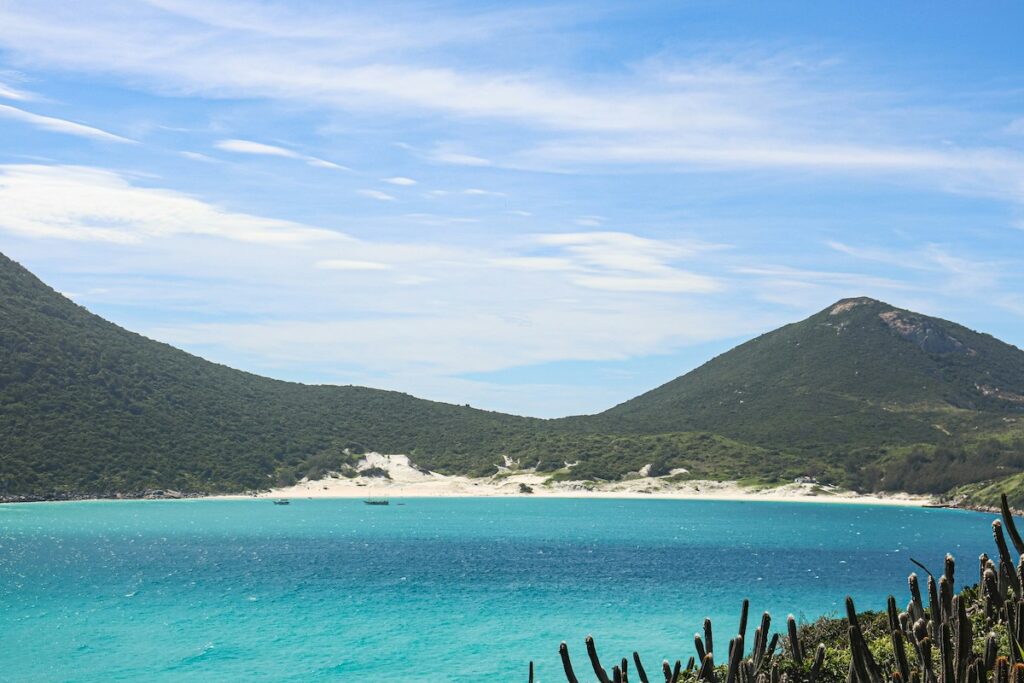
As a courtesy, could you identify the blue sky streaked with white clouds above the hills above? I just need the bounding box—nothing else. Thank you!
[0,0,1024,416]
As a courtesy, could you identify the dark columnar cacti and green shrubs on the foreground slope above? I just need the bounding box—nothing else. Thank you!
[529,498,1024,683]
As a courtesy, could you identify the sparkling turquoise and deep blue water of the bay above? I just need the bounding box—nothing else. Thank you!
[0,499,991,683]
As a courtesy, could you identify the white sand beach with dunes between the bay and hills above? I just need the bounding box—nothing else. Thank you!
[223,453,935,506]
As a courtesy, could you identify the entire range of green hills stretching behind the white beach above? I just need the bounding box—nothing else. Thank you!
[0,255,1024,496]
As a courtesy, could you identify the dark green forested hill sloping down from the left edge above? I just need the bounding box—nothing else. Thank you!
[0,256,552,494]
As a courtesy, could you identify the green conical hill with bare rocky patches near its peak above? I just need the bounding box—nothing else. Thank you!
[577,298,1024,490]
